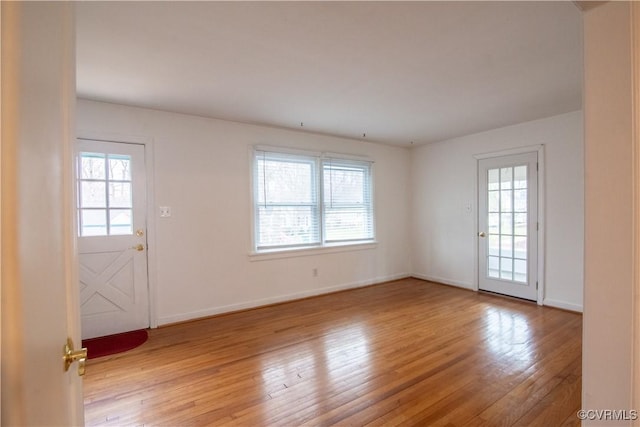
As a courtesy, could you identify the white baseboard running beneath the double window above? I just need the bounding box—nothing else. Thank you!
[158,273,412,326]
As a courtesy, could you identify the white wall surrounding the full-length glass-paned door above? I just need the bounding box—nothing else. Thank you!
[411,111,584,311]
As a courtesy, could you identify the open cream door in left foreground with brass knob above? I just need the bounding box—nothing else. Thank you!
[0,2,84,425]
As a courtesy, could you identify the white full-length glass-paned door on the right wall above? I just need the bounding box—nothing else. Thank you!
[478,153,538,301]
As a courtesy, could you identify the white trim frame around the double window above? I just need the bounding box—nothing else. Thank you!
[249,145,378,254]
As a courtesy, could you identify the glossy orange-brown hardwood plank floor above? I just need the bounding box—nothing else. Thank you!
[84,279,582,426]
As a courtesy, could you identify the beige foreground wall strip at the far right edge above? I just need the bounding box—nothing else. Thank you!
[582,2,640,425]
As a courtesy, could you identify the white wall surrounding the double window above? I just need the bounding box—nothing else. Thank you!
[77,100,411,324]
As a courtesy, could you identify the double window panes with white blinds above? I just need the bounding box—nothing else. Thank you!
[253,149,375,252]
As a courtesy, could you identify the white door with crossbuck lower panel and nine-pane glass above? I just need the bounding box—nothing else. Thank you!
[76,139,149,339]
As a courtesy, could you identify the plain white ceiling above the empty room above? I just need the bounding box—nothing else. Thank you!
[76,1,582,145]
